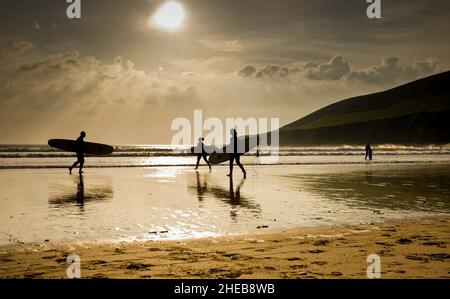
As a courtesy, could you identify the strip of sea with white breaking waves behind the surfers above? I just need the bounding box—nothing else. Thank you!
[0,145,450,169]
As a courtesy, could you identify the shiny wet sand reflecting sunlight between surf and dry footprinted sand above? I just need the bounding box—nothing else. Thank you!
[0,163,450,245]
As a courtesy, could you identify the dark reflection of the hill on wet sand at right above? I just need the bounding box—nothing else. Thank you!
[289,168,450,213]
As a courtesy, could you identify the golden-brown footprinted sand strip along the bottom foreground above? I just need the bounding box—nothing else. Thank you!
[0,217,450,278]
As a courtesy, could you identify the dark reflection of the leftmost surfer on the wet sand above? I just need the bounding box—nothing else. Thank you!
[48,174,113,211]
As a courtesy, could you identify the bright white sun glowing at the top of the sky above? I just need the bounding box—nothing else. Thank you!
[151,1,186,30]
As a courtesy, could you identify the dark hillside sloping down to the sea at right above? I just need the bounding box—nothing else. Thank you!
[280,71,450,145]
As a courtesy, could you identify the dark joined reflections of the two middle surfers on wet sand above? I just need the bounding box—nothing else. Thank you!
[189,172,261,220]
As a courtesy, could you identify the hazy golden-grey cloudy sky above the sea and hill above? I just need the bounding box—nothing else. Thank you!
[0,0,450,144]
